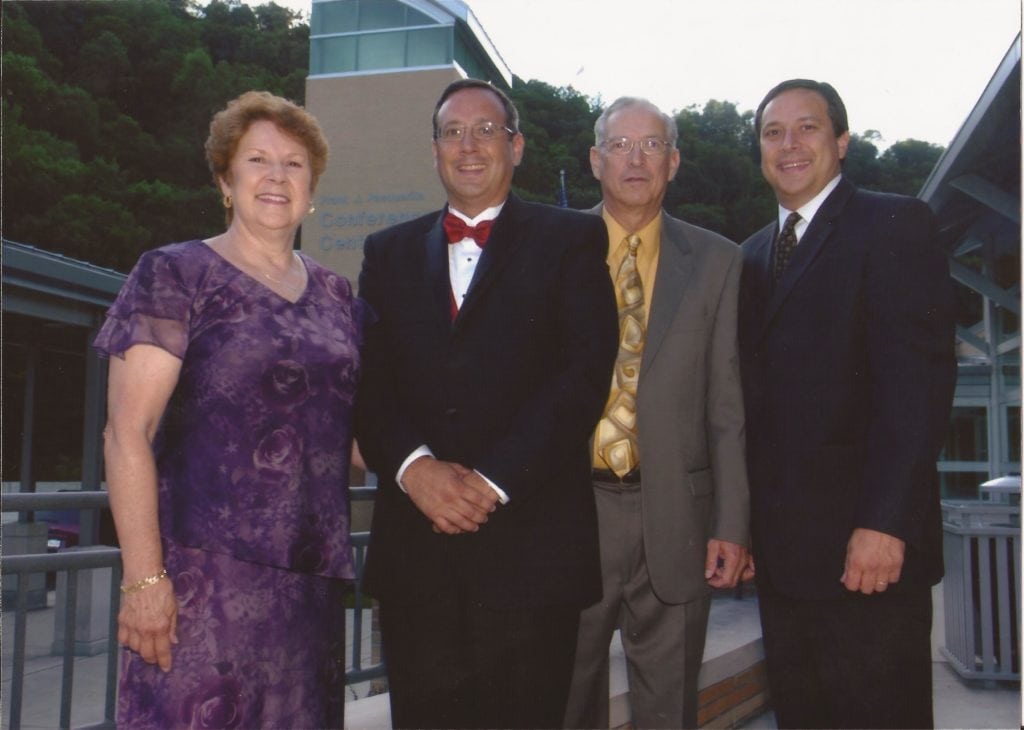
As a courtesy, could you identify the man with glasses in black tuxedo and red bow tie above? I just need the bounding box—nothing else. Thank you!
[356,80,617,728]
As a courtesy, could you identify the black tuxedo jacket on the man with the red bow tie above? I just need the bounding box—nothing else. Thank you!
[356,196,617,608]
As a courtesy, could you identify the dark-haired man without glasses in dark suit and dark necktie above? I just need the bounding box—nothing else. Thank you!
[739,79,955,728]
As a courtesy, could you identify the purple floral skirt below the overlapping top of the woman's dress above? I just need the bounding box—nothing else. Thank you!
[118,541,345,730]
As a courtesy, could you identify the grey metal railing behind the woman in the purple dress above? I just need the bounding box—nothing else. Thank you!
[0,486,387,730]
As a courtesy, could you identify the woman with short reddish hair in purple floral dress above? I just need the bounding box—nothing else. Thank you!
[95,92,367,728]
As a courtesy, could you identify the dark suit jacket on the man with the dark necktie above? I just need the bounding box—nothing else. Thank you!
[739,180,955,598]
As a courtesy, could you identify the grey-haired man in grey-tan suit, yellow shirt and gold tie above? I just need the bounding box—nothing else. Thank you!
[565,97,748,728]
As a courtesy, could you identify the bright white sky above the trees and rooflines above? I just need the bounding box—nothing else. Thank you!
[268,0,1021,147]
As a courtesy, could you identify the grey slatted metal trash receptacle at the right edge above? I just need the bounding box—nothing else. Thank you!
[941,477,1021,680]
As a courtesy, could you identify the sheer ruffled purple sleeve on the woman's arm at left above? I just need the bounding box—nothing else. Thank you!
[92,249,196,359]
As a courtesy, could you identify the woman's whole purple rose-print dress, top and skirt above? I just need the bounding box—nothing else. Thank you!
[94,241,372,728]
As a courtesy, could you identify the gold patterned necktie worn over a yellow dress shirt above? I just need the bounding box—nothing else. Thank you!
[594,233,646,478]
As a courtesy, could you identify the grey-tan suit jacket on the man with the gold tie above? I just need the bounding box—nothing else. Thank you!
[591,206,749,603]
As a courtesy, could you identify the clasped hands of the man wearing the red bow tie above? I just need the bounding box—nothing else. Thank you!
[401,457,498,534]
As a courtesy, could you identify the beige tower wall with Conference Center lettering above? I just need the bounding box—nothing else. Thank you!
[301,68,462,286]
